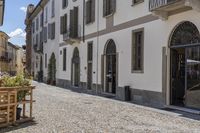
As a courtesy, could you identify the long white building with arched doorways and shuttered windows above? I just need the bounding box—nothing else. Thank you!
[26,0,200,109]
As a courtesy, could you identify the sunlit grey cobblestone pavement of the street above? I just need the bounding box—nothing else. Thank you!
[0,83,200,133]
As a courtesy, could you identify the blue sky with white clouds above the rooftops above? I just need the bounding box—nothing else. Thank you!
[0,0,39,46]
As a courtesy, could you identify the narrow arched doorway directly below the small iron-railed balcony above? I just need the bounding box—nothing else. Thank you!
[71,47,80,87]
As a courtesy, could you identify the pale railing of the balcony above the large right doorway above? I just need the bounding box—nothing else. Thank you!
[149,0,180,11]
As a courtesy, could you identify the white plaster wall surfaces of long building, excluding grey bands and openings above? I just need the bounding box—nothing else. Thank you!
[30,0,200,92]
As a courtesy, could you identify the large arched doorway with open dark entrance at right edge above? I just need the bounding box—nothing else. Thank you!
[170,21,200,109]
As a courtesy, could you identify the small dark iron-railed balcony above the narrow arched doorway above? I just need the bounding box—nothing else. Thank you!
[63,25,81,45]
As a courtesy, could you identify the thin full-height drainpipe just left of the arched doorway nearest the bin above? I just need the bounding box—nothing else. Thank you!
[96,0,99,94]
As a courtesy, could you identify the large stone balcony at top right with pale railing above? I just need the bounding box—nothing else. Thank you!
[149,0,200,20]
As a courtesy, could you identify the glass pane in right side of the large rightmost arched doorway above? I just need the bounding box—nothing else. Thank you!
[185,47,200,108]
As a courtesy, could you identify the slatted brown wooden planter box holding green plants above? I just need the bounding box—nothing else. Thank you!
[0,86,35,128]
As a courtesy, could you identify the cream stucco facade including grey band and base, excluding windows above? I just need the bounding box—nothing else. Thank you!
[26,0,200,107]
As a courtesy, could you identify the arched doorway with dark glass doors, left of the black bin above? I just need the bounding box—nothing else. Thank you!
[104,39,117,94]
